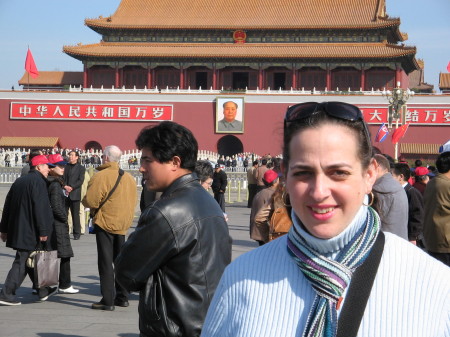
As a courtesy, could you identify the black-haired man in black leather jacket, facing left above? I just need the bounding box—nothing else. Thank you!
[115,122,231,337]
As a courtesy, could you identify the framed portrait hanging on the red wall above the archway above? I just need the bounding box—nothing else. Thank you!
[216,97,244,133]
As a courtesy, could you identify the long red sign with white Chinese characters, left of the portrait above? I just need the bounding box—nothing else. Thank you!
[10,102,173,122]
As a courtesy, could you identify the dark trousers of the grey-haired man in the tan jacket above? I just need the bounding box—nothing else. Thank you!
[95,225,128,306]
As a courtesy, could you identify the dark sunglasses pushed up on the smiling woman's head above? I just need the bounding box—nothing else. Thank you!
[284,102,372,146]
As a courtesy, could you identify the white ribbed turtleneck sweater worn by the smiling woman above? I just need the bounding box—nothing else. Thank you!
[202,208,450,337]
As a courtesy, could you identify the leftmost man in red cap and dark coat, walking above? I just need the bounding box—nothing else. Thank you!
[0,155,58,306]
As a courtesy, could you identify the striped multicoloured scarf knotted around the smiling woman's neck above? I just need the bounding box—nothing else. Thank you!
[287,207,380,337]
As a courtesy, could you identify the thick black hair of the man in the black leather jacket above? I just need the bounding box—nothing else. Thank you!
[136,122,198,171]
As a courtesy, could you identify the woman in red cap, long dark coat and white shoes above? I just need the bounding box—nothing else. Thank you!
[47,154,79,294]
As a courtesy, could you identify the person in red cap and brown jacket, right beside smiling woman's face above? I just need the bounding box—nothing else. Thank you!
[250,170,280,246]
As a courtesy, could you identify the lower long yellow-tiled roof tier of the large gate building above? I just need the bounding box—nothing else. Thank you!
[63,42,416,59]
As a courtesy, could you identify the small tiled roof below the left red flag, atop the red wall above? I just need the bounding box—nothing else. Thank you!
[19,71,83,85]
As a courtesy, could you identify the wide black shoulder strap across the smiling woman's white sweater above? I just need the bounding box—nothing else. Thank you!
[336,231,385,337]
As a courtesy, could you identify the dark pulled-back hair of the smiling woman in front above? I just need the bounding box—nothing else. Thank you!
[283,110,372,170]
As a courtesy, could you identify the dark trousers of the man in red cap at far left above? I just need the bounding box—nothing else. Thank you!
[0,250,30,301]
